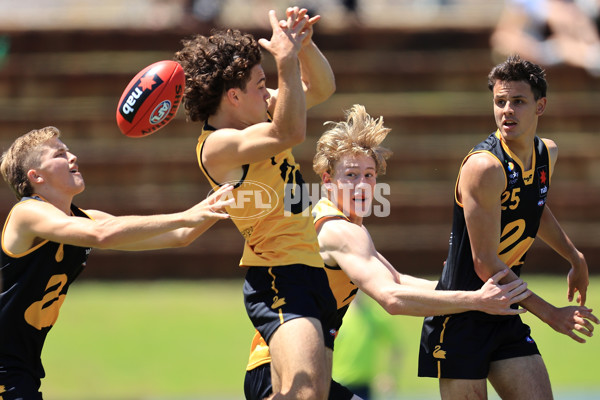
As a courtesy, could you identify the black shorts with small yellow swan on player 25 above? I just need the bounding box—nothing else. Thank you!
[419,312,540,379]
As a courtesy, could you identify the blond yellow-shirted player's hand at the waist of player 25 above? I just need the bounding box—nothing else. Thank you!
[477,268,531,315]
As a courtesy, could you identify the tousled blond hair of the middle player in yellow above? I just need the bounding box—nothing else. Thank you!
[313,104,392,176]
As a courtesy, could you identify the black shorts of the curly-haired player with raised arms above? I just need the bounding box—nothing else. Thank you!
[244,264,340,350]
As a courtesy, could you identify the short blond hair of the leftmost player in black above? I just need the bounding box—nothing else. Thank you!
[0,126,60,200]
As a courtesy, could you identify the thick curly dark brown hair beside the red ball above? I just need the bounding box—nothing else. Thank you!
[174,29,262,121]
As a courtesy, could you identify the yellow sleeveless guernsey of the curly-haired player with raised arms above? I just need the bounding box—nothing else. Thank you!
[196,124,323,268]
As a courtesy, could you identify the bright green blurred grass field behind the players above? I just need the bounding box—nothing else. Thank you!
[42,275,600,400]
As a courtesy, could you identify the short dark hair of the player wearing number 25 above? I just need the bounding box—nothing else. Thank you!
[488,54,548,100]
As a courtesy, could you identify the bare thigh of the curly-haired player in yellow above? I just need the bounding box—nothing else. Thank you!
[269,318,332,394]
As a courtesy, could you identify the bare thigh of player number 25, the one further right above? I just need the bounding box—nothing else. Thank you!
[488,354,553,400]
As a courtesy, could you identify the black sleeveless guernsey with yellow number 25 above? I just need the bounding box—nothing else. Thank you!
[438,131,551,302]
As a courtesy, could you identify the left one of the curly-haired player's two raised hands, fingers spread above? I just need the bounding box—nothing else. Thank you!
[258,7,312,62]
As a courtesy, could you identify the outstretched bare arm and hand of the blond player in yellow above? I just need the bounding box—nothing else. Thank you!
[318,220,529,316]
